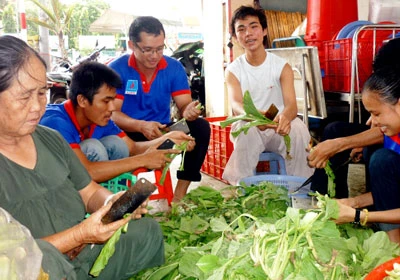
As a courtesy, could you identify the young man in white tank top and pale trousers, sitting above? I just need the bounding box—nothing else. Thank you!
[223,6,313,185]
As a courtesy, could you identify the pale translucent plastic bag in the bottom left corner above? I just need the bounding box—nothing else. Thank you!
[0,208,43,280]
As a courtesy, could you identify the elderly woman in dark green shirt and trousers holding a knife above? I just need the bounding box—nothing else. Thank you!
[0,36,164,279]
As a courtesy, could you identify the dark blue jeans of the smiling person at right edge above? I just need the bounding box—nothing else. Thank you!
[369,148,400,231]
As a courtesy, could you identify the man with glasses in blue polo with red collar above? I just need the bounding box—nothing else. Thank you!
[109,16,210,201]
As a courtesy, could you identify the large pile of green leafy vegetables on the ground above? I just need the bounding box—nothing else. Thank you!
[131,182,400,280]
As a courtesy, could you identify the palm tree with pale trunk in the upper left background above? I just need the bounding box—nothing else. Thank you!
[27,0,75,59]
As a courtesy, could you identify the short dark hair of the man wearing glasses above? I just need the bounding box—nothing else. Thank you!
[129,16,165,43]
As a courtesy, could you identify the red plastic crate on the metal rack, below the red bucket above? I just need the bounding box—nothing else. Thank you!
[323,36,386,92]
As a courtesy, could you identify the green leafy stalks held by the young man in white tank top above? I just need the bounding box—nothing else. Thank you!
[221,91,291,159]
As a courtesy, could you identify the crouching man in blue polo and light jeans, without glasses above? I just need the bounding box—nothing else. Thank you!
[40,62,194,182]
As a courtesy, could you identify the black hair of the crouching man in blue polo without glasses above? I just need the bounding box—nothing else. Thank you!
[69,61,122,106]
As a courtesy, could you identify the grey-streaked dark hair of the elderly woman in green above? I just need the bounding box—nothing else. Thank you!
[0,35,46,92]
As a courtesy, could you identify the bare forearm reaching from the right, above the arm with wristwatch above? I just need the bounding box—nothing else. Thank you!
[308,127,383,168]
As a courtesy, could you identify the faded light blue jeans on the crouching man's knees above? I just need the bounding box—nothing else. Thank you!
[79,135,129,161]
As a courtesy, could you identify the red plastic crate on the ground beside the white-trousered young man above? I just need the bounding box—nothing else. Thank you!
[201,116,269,183]
